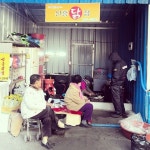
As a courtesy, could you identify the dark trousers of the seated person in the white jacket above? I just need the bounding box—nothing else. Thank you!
[32,106,58,137]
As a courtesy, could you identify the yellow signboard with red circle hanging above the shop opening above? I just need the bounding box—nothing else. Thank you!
[45,3,100,22]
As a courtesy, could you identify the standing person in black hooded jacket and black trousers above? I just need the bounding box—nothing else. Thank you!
[109,52,127,118]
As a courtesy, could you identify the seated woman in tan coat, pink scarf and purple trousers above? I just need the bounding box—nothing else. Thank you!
[64,75,93,127]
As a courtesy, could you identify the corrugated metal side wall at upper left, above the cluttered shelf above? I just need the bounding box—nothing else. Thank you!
[0,4,34,41]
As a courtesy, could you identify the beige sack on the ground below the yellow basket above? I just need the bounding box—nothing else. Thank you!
[8,112,23,137]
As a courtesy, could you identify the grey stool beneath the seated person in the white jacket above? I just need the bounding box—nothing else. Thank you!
[23,119,42,142]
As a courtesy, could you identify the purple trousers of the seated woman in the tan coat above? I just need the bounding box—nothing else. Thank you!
[79,103,93,121]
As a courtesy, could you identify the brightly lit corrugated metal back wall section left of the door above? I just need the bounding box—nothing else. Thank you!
[40,29,70,73]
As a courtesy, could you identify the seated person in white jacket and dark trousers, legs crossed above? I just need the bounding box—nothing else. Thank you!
[21,74,64,149]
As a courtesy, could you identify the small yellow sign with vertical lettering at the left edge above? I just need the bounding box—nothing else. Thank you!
[0,53,10,81]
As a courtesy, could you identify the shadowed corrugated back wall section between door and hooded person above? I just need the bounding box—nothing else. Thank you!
[94,29,119,69]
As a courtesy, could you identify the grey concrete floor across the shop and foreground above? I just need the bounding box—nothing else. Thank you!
[0,110,131,150]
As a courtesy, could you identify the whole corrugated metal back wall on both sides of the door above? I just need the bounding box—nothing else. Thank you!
[40,28,118,73]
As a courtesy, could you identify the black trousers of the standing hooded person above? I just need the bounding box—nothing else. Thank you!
[111,85,125,114]
